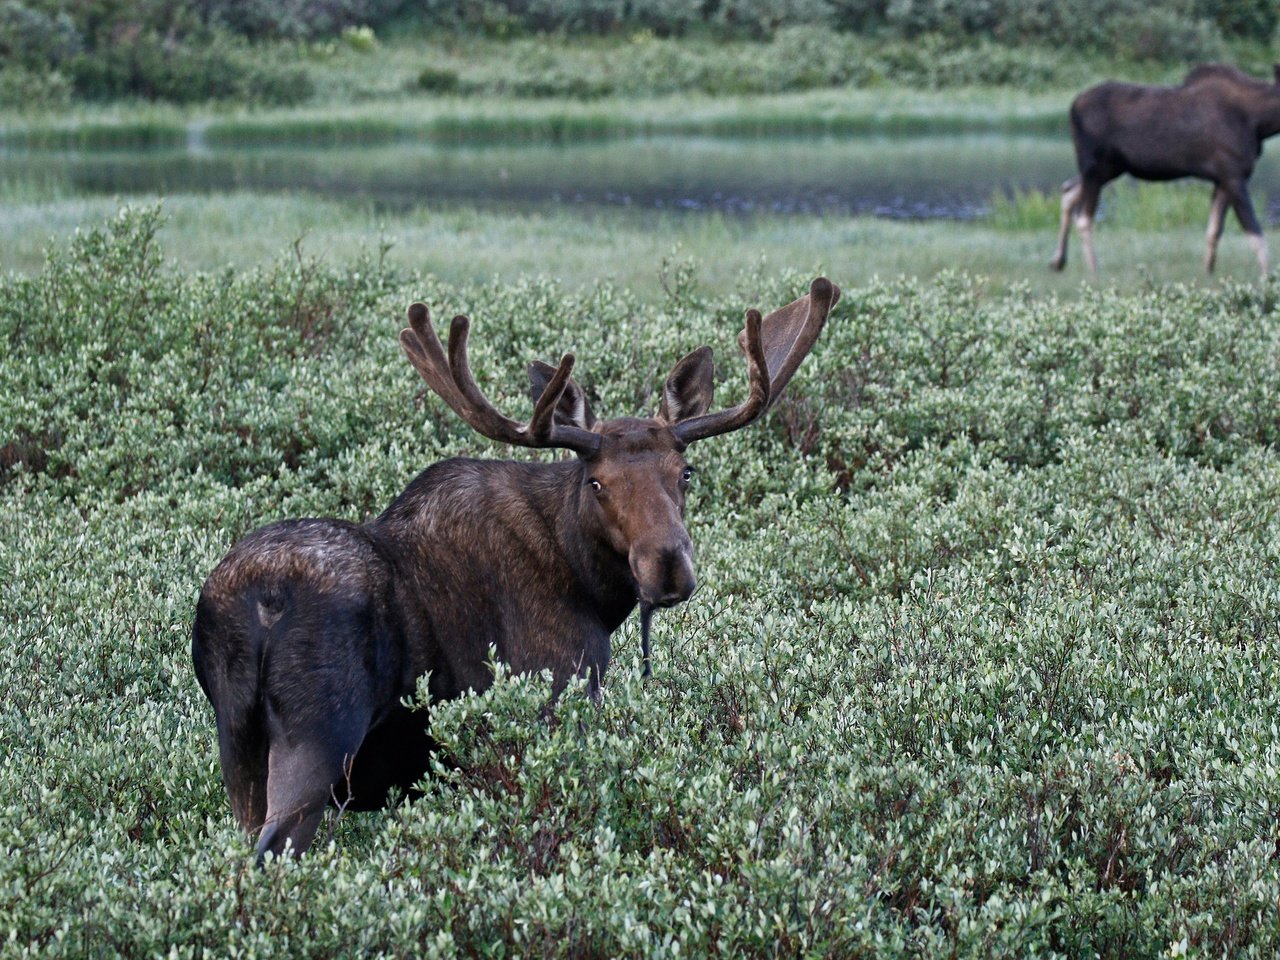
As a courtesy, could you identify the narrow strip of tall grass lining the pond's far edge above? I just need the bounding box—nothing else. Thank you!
[0,88,1070,148]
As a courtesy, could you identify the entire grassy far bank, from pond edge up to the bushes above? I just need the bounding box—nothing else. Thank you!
[0,29,1213,148]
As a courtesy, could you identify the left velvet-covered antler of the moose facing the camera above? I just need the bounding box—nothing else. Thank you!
[401,303,600,457]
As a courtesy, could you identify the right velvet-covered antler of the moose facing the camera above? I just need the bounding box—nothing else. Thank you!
[672,276,840,443]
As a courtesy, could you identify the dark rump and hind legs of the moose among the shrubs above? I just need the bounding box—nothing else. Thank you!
[192,520,414,851]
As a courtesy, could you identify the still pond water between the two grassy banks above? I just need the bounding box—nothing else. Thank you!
[0,134,1280,220]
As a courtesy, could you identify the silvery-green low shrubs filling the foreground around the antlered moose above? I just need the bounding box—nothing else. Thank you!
[0,204,1280,957]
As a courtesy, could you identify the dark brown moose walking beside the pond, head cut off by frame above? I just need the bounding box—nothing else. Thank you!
[1050,64,1280,275]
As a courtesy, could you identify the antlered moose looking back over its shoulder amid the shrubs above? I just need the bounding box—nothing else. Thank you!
[192,276,840,863]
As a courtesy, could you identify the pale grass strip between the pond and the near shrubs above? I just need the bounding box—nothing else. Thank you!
[0,183,1257,300]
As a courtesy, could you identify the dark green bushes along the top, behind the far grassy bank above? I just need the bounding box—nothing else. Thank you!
[0,0,1277,109]
